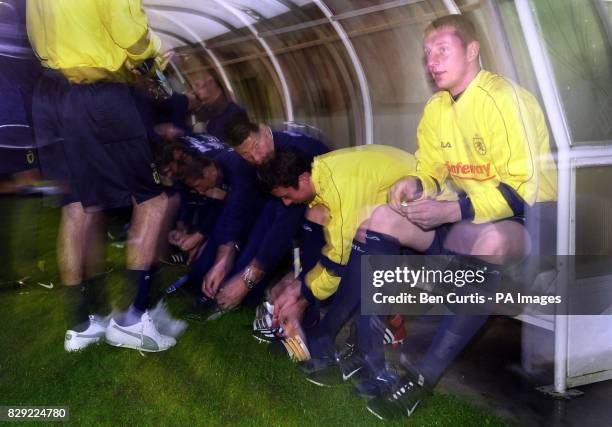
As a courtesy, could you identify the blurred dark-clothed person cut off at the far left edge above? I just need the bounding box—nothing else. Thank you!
[0,0,45,287]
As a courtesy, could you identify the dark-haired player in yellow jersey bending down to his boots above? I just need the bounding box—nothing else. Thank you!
[260,145,415,372]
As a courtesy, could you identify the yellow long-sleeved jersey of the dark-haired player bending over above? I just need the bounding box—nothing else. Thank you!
[305,145,416,300]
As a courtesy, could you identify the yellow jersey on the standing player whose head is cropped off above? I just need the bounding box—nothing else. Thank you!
[27,0,161,83]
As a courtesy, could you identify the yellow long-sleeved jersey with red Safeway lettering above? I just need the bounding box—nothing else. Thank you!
[416,71,557,223]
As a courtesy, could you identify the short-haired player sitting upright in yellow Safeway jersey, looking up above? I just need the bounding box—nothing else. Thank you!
[368,15,557,419]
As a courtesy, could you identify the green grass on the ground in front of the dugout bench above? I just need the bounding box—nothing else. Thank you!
[0,199,505,426]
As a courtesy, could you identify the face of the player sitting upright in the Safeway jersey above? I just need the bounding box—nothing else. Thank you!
[423,27,478,96]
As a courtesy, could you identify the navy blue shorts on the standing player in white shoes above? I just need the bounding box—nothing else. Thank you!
[33,70,162,209]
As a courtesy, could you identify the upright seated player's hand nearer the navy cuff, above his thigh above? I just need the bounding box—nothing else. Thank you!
[402,199,461,230]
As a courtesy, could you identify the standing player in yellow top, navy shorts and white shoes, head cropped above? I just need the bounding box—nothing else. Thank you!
[27,0,176,351]
